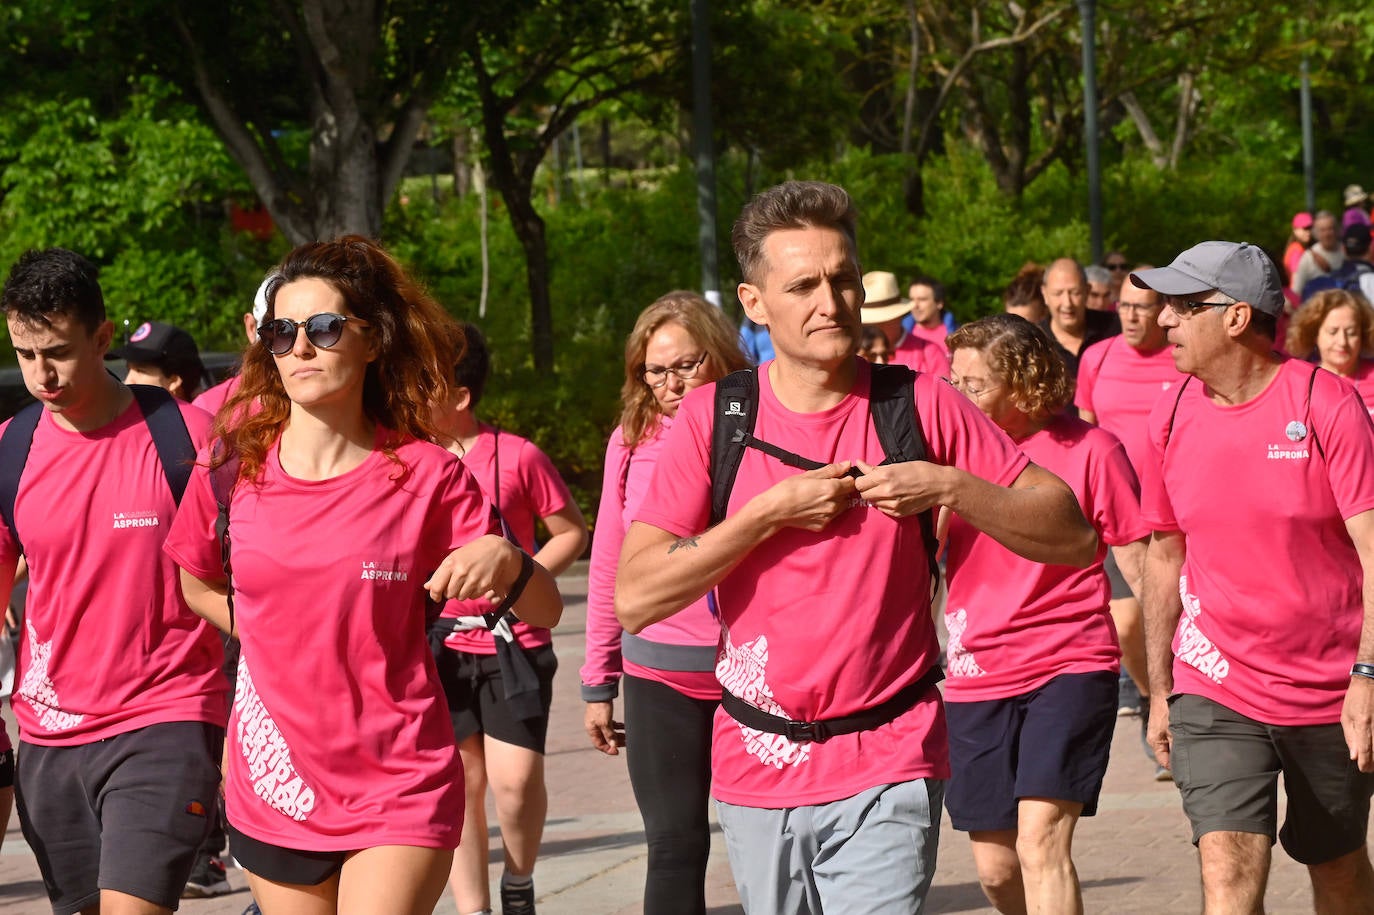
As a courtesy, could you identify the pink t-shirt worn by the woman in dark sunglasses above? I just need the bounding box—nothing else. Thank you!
[166,430,496,852]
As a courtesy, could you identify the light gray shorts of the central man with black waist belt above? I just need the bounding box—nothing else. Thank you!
[716,779,944,915]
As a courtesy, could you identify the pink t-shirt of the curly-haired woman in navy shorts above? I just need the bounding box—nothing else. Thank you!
[945,415,1150,702]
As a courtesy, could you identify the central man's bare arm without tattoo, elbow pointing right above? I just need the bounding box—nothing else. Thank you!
[856,460,1098,567]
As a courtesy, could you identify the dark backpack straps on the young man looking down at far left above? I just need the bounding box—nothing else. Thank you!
[0,385,195,554]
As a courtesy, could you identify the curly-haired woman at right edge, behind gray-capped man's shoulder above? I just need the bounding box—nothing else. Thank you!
[1287,289,1374,412]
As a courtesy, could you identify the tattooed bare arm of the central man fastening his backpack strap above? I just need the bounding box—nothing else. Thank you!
[616,464,855,632]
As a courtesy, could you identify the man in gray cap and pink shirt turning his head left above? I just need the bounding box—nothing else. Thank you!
[1131,242,1374,912]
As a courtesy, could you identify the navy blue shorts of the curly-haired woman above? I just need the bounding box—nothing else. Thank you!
[945,670,1117,833]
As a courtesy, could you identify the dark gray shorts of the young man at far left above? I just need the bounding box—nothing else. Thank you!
[15,721,224,915]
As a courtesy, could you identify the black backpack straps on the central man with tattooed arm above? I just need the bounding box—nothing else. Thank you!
[710,364,940,583]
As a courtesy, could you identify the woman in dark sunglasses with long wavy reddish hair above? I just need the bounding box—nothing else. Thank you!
[165,236,562,915]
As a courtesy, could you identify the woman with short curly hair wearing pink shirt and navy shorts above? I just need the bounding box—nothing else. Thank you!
[944,315,1149,912]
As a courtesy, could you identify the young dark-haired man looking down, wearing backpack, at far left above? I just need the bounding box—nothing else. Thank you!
[0,249,227,915]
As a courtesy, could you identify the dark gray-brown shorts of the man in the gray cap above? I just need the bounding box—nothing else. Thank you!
[1169,695,1374,864]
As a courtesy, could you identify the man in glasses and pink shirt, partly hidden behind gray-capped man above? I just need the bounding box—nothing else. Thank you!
[1073,274,1183,758]
